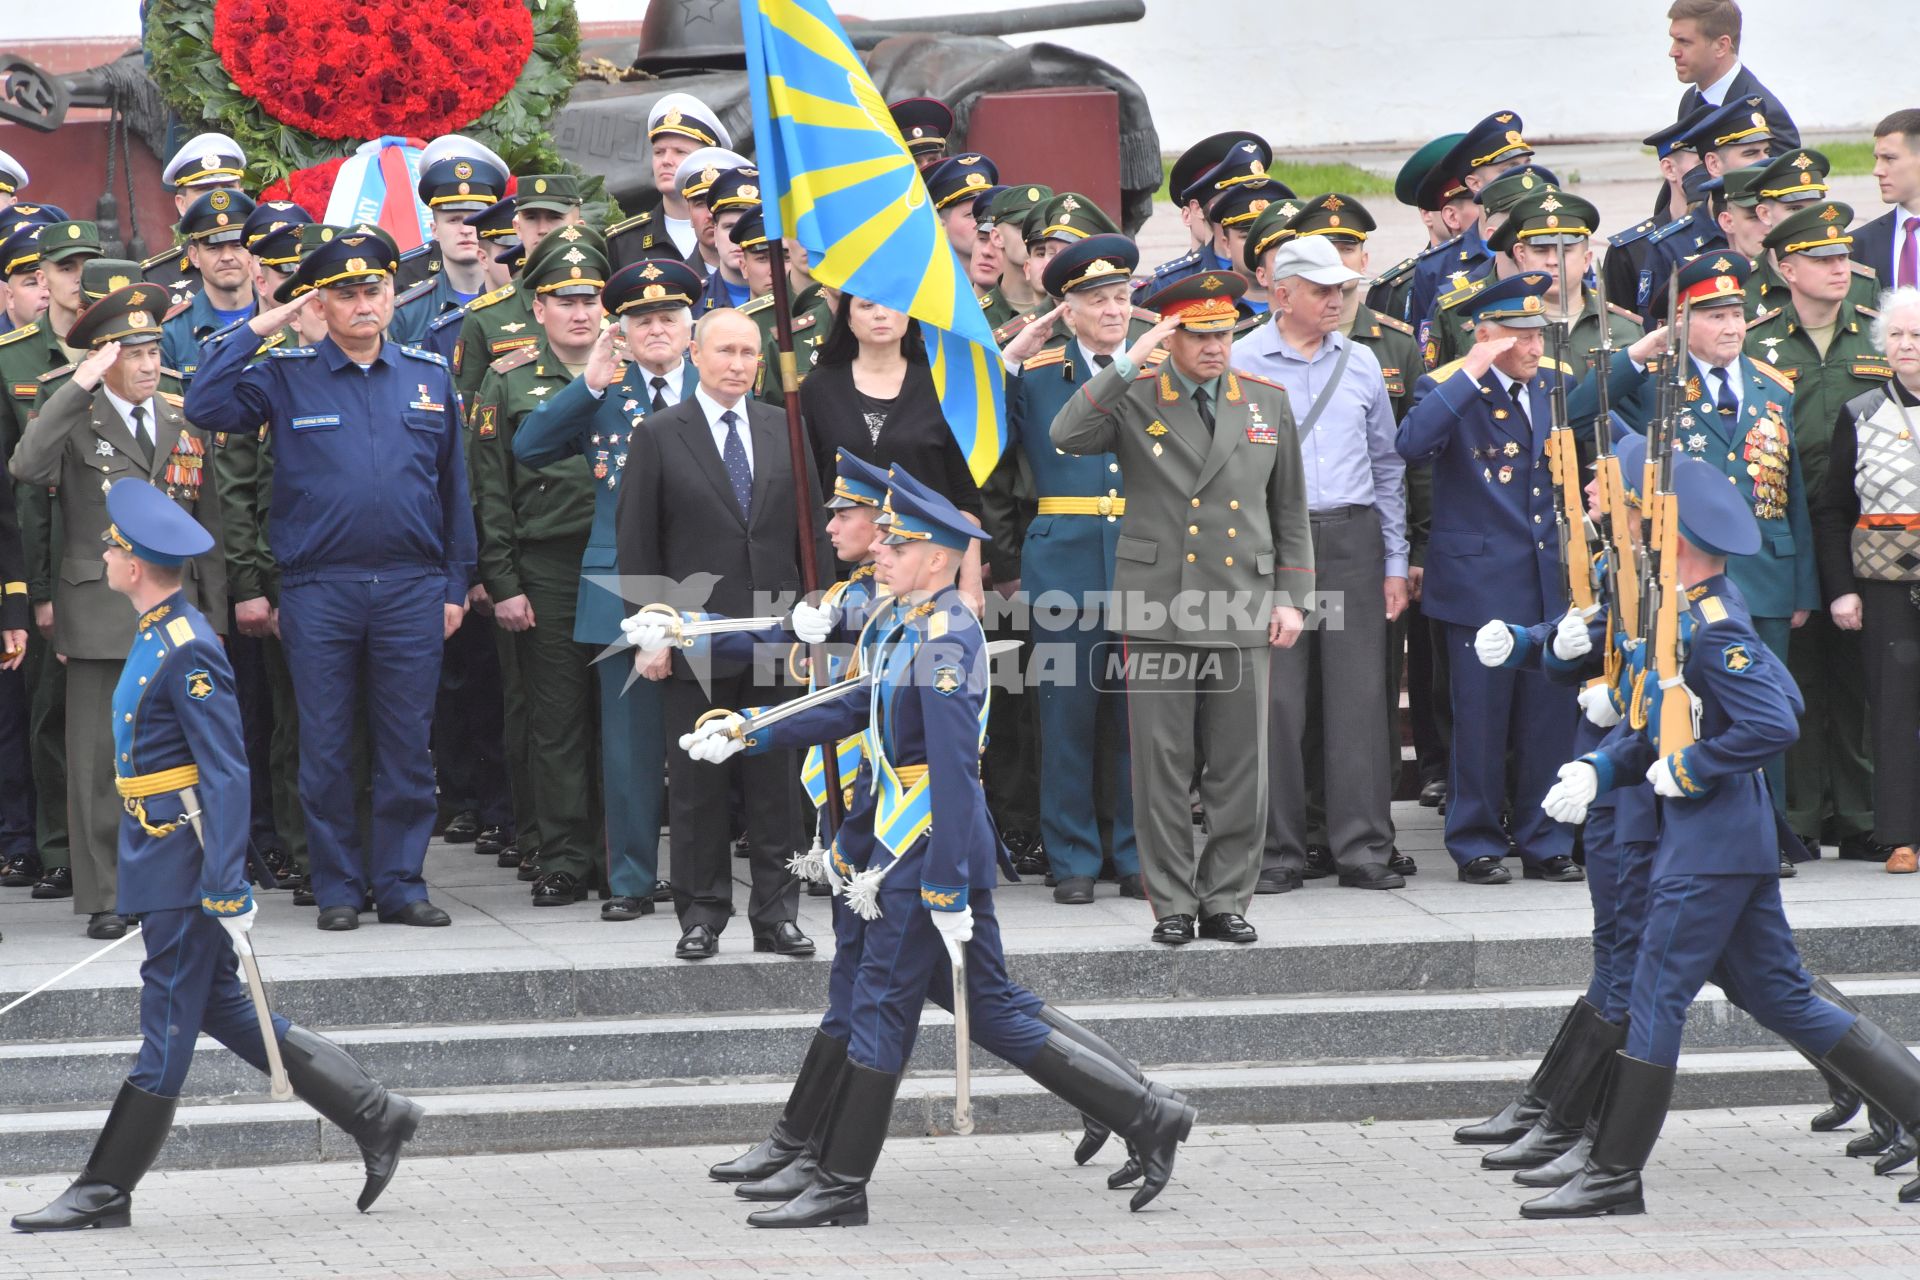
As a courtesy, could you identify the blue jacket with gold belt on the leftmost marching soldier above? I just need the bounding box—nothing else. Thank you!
[113,591,252,915]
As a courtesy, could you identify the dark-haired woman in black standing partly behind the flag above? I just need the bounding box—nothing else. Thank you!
[801,294,981,612]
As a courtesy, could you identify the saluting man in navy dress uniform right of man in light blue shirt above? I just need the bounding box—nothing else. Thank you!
[1400,273,1580,885]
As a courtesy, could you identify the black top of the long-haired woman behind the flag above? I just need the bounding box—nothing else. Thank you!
[801,361,981,516]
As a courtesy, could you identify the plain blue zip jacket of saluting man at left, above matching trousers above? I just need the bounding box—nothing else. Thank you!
[186,324,474,604]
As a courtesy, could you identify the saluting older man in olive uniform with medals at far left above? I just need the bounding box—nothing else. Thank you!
[12,282,224,938]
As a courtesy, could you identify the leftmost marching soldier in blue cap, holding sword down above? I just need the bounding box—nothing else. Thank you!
[13,477,426,1232]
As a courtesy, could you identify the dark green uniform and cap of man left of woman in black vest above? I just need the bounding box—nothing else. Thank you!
[1745,201,1893,842]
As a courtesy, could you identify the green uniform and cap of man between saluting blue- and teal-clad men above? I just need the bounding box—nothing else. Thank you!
[467,226,609,904]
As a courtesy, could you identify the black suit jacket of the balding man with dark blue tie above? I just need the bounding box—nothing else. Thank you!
[614,397,833,679]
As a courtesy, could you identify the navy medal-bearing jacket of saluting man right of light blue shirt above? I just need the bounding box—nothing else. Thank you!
[1398,361,1567,628]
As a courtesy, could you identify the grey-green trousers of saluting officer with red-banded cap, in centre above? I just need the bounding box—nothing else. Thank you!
[1125,637,1267,919]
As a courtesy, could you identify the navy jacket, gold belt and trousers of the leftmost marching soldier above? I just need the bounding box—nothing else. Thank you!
[113,591,286,1098]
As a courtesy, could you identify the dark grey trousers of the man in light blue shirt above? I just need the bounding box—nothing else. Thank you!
[1261,507,1394,873]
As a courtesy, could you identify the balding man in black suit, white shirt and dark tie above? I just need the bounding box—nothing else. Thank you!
[614,307,831,960]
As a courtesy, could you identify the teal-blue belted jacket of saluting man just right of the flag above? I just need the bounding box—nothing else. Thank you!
[1006,342,1125,608]
